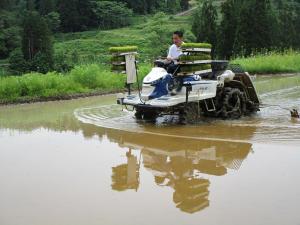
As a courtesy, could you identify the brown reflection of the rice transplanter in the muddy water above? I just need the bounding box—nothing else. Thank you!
[108,131,251,213]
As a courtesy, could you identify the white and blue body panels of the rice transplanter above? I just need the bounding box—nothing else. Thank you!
[122,67,235,108]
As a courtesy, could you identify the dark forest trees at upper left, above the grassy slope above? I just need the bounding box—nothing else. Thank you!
[0,0,189,74]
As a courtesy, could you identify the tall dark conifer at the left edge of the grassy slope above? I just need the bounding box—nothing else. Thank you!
[22,12,53,72]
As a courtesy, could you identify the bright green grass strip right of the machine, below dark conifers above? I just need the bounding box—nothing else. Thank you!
[232,50,300,74]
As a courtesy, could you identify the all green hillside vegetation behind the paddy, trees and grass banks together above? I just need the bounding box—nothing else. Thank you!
[0,0,300,103]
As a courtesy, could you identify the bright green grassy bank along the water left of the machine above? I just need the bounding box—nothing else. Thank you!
[0,64,150,103]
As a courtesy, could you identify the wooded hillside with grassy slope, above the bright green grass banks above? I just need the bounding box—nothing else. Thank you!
[0,0,300,74]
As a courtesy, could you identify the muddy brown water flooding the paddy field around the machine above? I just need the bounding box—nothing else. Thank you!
[0,75,300,225]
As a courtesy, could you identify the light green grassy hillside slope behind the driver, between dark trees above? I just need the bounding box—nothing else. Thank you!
[54,13,191,64]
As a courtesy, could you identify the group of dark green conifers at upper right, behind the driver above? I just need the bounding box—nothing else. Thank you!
[193,0,300,58]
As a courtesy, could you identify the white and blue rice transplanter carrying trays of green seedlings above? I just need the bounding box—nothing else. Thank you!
[111,43,260,124]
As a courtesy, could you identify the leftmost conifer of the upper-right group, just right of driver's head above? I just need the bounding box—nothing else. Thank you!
[192,0,218,55]
